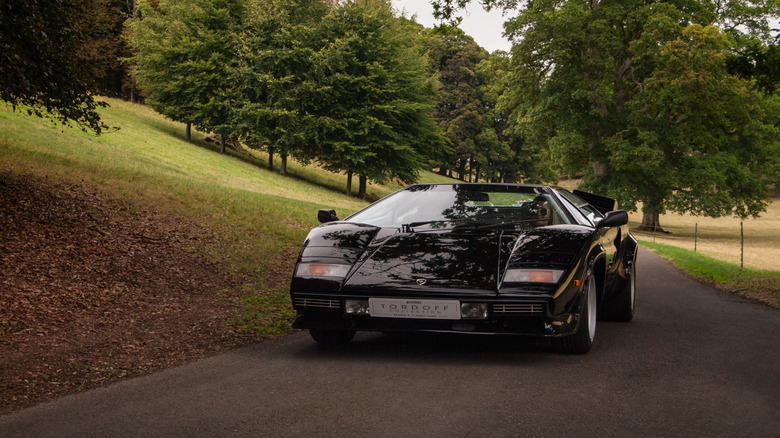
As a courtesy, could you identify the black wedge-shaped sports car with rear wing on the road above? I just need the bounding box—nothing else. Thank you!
[290,184,637,353]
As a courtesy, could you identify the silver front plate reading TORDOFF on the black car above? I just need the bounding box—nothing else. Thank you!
[368,298,460,319]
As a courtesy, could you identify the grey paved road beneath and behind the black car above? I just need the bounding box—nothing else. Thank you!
[0,251,780,437]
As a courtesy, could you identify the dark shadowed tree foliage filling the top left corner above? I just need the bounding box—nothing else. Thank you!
[0,0,108,134]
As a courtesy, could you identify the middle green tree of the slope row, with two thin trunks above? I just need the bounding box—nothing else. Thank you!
[234,0,328,175]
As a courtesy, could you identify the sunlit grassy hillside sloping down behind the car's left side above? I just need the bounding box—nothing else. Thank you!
[0,99,458,290]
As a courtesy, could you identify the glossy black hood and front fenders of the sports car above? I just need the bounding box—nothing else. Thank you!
[291,222,593,296]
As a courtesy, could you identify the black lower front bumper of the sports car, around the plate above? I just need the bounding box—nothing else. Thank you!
[293,294,579,337]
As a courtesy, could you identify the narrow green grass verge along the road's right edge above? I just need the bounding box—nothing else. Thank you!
[640,241,780,308]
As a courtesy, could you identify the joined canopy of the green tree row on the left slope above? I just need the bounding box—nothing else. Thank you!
[128,0,442,195]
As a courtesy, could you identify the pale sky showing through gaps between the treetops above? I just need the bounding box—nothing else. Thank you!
[393,0,512,53]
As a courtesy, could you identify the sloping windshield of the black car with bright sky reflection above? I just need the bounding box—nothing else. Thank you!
[346,184,570,231]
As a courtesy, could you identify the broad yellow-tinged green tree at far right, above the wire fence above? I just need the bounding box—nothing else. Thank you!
[607,25,780,229]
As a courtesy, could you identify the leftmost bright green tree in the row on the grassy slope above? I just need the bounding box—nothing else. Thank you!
[127,0,244,149]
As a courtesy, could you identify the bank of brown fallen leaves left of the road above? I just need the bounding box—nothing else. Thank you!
[0,173,286,414]
